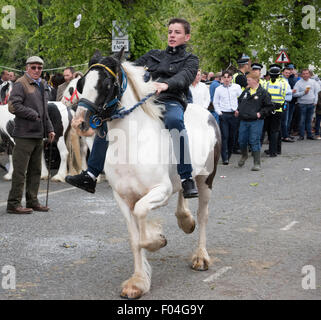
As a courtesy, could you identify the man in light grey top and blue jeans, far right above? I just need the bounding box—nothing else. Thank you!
[293,69,318,140]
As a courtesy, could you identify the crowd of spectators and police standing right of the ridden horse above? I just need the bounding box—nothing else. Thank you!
[190,57,321,170]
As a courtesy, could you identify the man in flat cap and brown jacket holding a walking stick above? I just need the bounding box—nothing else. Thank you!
[7,56,55,214]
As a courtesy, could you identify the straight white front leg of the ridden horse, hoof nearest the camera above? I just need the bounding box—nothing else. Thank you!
[114,192,152,299]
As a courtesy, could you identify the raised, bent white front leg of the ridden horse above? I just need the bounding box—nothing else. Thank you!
[133,183,172,251]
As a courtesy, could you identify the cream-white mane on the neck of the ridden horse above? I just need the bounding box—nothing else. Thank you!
[122,61,164,120]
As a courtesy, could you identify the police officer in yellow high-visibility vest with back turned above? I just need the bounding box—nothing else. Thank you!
[263,64,288,157]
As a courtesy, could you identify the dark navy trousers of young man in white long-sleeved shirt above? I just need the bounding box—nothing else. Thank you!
[220,112,238,162]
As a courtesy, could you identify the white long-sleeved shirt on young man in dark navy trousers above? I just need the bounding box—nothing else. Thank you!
[213,83,242,115]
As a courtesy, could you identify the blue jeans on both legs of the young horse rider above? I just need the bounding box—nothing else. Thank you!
[88,101,193,179]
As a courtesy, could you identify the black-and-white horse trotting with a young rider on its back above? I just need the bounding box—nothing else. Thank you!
[73,50,221,299]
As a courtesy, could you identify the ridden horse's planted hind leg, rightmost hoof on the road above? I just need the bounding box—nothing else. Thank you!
[192,176,211,271]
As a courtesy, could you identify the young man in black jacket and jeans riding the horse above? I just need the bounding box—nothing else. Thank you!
[66,18,199,198]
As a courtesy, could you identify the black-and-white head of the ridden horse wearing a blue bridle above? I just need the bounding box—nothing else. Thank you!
[73,49,125,135]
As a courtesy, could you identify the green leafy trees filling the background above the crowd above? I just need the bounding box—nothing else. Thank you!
[0,0,321,71]
